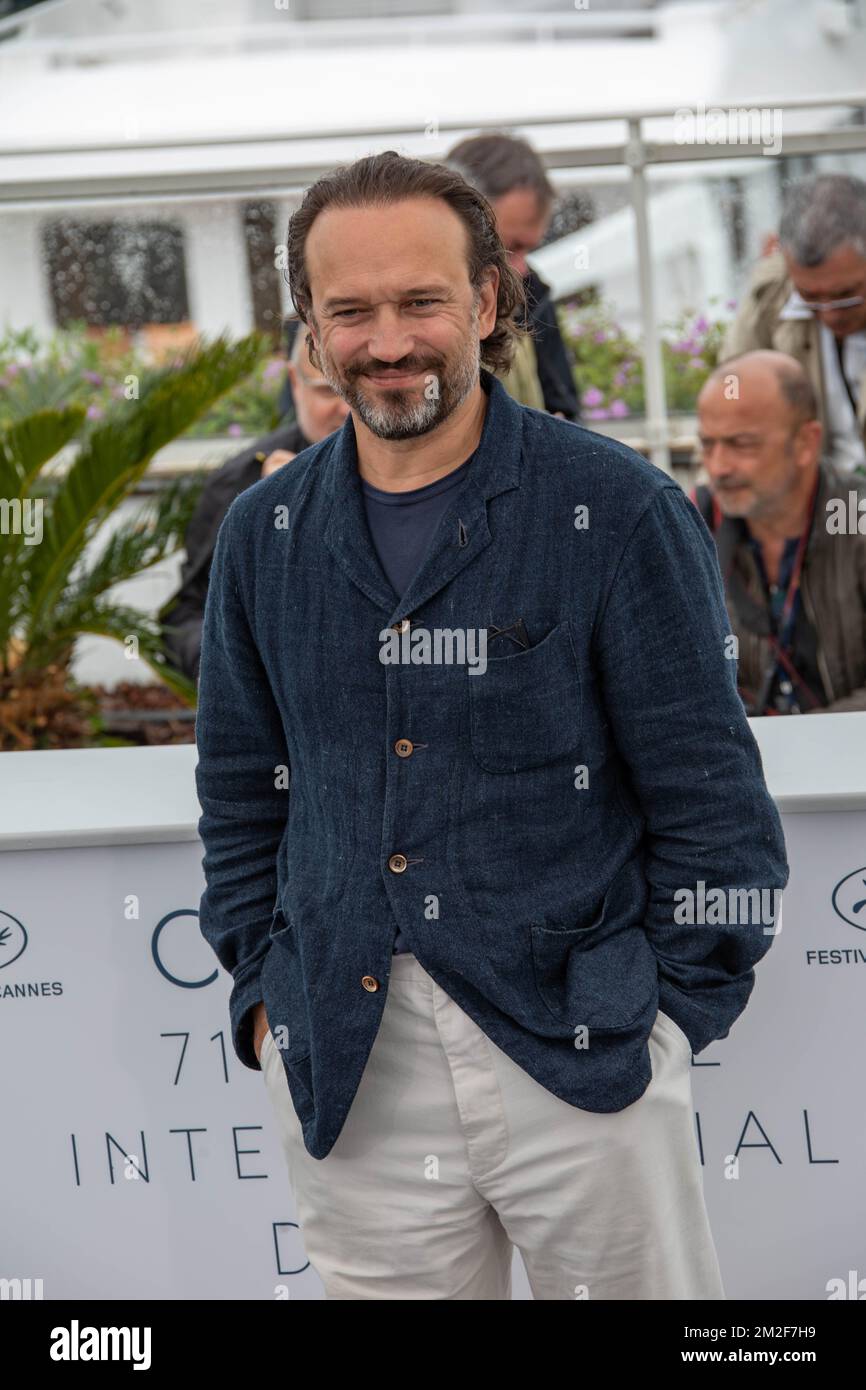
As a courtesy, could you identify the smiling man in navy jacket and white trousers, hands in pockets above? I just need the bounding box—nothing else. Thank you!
[196,152,788,1301]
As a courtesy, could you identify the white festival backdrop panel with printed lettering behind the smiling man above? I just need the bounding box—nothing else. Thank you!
[0,811,866,1300]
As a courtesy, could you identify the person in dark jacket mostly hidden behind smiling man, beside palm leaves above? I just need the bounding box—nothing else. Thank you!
[161,334,349,681]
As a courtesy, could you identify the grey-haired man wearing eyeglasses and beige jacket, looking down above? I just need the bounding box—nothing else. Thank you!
[721,174,866,474]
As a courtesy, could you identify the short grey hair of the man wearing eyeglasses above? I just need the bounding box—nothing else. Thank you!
[778,174,866,267]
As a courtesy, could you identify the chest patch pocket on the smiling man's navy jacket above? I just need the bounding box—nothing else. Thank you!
[466,623,581,773]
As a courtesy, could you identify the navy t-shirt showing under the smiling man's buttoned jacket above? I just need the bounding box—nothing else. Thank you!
[360,453,474,952]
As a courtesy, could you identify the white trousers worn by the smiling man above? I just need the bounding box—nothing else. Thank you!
[261,954,726,1301]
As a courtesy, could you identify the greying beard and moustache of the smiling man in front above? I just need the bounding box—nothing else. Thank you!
[318,328,481,439]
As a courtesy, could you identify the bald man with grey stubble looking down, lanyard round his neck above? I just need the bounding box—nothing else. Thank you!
[692,349,866,714]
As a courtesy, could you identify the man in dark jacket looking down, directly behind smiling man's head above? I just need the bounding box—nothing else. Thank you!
[446,132,580,421]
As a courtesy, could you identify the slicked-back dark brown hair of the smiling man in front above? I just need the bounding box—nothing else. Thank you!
[286,150,525,373]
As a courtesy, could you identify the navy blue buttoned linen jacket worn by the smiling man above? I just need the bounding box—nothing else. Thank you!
[196,371,788,1158]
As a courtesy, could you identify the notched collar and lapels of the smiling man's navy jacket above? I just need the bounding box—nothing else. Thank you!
[318,368,523,623]
